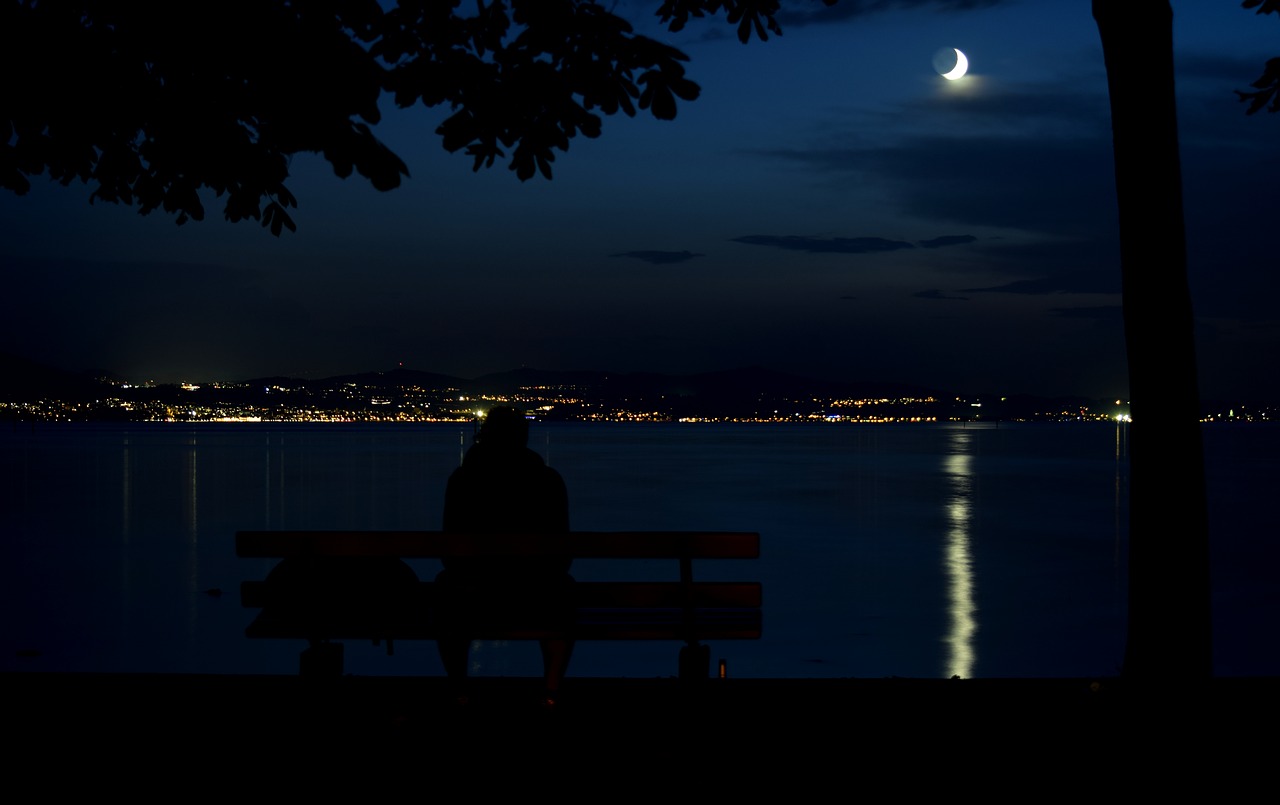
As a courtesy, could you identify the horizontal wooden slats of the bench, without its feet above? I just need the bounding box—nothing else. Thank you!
[236,531,762,641]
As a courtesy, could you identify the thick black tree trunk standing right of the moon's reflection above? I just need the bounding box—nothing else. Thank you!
[1093,0,1212,683]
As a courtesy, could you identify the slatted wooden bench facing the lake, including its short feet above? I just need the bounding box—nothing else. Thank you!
[236,531,762,678]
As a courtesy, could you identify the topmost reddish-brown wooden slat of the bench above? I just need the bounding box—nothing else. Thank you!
[236,531,760,559]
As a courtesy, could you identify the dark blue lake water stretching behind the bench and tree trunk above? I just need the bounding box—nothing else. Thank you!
[0,424,1280,677]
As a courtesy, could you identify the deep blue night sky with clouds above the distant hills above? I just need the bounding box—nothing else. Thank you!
[0,0,1280,401]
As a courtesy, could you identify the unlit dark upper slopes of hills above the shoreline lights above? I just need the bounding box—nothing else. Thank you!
[0,352,1157,420]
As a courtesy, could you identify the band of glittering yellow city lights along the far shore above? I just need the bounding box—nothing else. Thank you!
[0,380,1264,425]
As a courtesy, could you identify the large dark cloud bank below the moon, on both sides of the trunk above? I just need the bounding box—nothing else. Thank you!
[747,64,1280,325]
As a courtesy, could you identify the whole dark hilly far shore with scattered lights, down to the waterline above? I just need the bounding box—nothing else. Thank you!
[0,353,1198,422]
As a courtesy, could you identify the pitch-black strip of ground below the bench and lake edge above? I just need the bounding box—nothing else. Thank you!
[0,673,1280,801]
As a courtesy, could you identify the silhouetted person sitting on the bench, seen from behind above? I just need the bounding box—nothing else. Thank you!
[436,407,573,705]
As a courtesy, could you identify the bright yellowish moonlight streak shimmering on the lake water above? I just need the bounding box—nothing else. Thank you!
[943,430,978,678]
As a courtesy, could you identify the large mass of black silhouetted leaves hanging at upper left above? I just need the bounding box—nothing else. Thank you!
[0,0,835,234]
